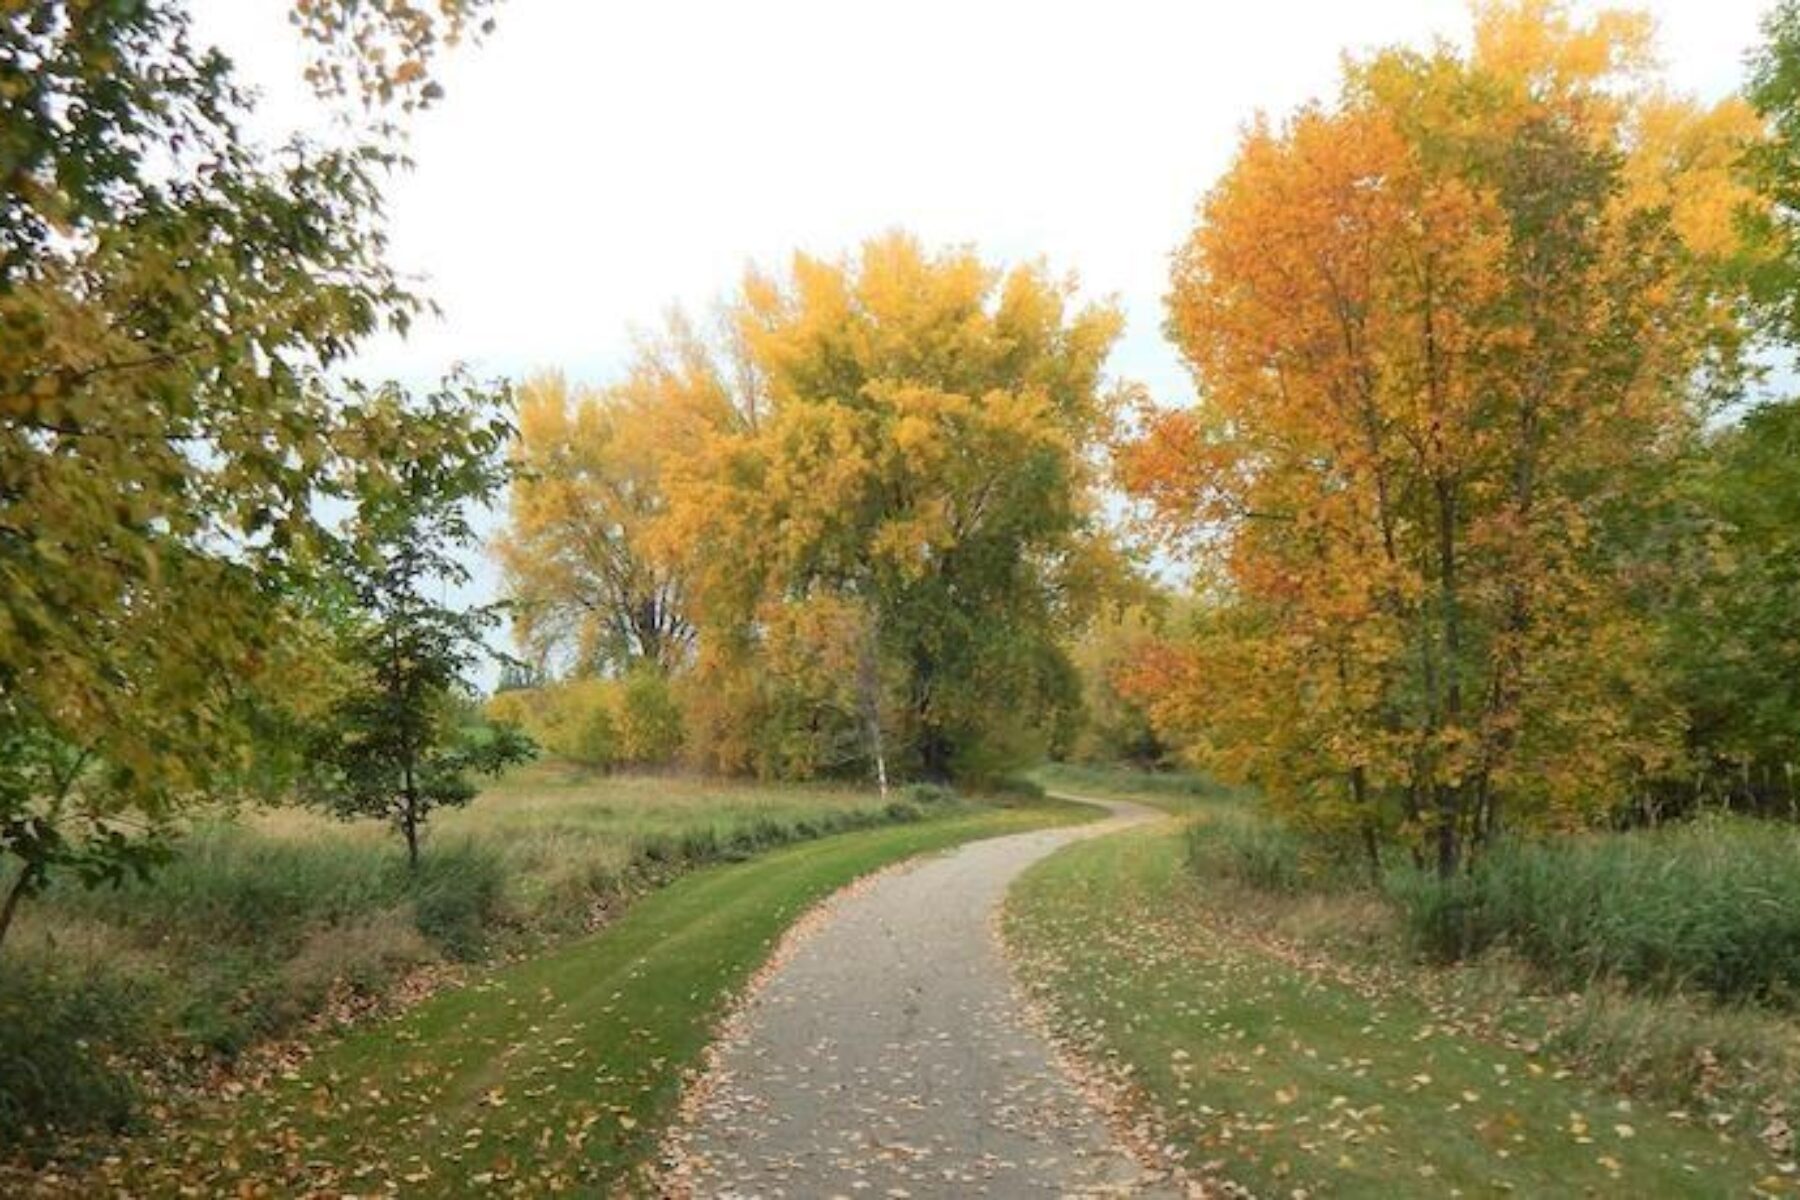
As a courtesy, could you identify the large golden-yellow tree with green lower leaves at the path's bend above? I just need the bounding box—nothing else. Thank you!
[670,234,1120,777]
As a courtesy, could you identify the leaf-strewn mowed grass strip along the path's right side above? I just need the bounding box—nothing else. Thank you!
[1004,822,1791,1196]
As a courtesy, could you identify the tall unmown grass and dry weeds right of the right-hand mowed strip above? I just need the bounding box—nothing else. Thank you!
[1152,780,1800,1141]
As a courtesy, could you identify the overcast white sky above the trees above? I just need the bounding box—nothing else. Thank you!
[194,0,1771,408]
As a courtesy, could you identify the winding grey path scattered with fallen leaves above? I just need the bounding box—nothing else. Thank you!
[673,804,1177,1200]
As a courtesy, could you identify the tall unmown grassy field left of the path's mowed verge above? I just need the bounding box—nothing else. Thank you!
[0,763,956,1159]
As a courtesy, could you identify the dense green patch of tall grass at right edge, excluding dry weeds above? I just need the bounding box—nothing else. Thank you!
[1390,820,1800,1007]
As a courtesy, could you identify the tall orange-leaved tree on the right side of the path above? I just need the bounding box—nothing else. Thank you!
[1123,2,1755,874]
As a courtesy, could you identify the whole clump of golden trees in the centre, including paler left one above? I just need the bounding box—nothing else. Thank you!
[500,234,1121,775]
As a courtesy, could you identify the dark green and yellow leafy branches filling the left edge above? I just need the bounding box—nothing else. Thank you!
[0,0,500,934]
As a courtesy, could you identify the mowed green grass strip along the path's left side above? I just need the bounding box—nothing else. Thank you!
[72,802,1094,1195]
